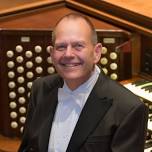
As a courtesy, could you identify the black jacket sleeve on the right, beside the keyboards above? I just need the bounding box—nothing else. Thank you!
[111,103,148,152]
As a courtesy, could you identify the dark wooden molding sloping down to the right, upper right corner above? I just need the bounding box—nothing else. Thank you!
[72,0,152,35]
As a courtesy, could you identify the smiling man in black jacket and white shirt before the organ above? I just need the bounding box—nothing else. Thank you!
[19,13,148,152]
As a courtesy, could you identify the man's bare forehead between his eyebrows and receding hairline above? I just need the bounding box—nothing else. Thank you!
[54,18,92,43]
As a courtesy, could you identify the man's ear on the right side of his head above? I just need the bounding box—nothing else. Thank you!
[94,43,102,63]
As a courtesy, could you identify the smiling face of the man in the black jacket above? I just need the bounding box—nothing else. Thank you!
[51,19,101,89]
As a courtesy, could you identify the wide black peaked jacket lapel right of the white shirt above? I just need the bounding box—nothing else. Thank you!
[66,75,112,152]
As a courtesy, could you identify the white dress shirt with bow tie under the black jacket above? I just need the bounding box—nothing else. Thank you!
[48,66,100,152]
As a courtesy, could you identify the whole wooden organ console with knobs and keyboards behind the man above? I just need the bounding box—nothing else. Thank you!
[0,0,152,152]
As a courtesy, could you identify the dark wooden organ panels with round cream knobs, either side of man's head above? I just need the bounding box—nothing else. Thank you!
[0,29,131,137]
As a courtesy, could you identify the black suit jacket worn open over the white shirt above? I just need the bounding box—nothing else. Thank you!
[19,73,148,152]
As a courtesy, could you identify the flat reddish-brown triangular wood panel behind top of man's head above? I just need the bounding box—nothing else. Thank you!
[0,6,120,29]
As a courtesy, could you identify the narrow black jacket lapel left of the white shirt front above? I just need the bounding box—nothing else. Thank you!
[39,74,63,152]
